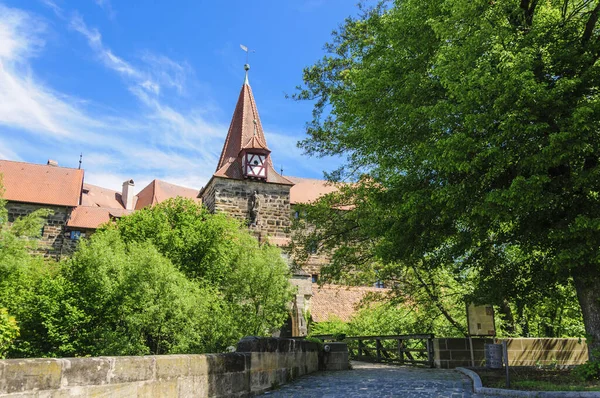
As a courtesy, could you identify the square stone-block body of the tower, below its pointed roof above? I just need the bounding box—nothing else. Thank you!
[202,177,291,238]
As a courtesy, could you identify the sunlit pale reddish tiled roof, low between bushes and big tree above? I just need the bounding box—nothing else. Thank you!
[310,283,387,322]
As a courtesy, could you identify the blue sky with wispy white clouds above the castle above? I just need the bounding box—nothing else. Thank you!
[0,0,357,190]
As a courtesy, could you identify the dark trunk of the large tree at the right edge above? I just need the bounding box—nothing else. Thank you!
[573,270,600,360]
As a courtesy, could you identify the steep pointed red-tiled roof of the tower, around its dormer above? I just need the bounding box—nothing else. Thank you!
[214,64,294,185]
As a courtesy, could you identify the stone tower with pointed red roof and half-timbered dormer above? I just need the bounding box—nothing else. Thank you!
[198,64,294,245]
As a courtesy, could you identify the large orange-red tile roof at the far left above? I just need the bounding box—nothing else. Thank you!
[0,160,83,207]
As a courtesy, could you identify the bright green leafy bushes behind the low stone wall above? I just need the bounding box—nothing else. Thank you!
[0,193,292,357]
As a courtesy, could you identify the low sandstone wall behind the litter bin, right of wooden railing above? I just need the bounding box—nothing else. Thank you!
[433,338,588,369]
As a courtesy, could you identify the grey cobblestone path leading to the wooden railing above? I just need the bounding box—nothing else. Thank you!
[263,362,502,398]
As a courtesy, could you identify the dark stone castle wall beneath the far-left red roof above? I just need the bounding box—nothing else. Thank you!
[6,202,71,257]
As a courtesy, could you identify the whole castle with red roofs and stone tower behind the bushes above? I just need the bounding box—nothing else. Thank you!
[0,65,384,336]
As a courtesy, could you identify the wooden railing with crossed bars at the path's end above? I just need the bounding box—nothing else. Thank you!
[312,334,434,368]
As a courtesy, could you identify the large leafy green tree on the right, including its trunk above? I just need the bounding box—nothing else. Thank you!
[296,0,600,354]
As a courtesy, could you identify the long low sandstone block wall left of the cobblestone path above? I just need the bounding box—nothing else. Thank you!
[0,338,319,398]
